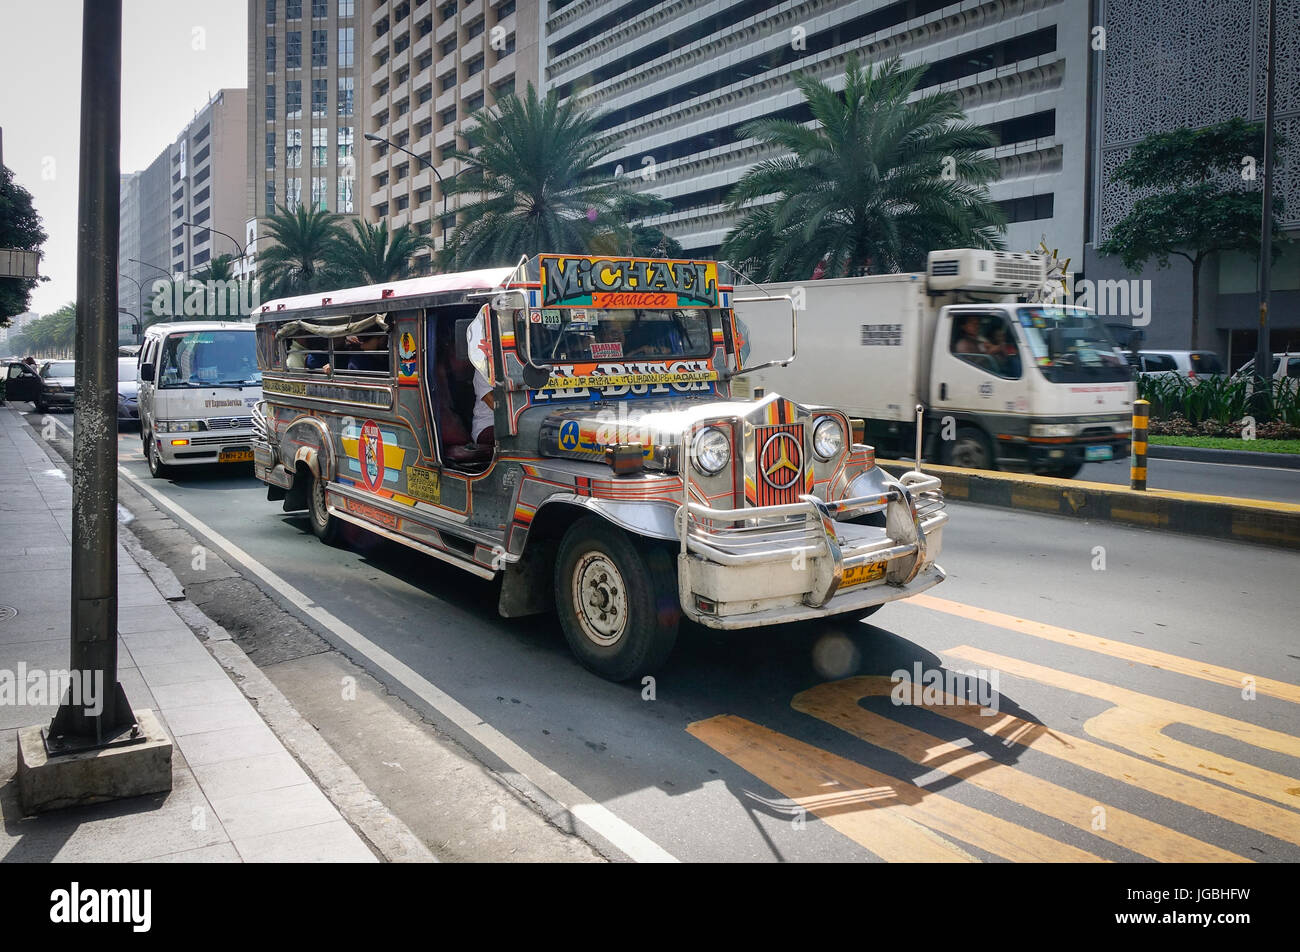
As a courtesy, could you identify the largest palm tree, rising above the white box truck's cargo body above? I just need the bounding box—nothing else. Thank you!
[723,56,1006,281]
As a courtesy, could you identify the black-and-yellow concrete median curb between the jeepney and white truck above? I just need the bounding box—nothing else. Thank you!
[876,459,1300,549]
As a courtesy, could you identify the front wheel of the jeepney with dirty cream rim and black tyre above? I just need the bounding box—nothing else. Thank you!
[555,516,681,681]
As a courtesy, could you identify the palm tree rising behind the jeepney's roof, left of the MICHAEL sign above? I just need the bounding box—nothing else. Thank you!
[441,83,627,268]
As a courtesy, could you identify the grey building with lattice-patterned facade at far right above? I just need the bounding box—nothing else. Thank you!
[1086,0,1300,356]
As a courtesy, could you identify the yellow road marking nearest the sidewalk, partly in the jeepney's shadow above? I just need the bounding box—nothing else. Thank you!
[686,714,1101,862]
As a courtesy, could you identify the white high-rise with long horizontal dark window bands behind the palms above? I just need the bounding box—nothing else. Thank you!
[545,0,1089,261]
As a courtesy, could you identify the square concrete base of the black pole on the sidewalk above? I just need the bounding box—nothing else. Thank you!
[17,710,172,814]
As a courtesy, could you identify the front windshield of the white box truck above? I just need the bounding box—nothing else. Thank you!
[1017,306,1132,384]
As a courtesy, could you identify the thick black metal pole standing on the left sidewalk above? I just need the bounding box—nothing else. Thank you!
[48,0,133,749]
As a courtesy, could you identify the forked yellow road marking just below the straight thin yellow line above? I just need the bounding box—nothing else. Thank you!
[945,645,1300,806]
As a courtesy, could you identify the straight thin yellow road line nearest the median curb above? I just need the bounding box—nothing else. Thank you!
[901,594,1300,704]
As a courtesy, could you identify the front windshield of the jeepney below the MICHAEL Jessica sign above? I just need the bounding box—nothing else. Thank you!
[516,307,712,364]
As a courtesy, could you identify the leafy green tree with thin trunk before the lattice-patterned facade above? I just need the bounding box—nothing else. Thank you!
[1097,117,1284,350]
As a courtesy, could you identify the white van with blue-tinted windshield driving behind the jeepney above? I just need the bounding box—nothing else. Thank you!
[138,321,261,479]
